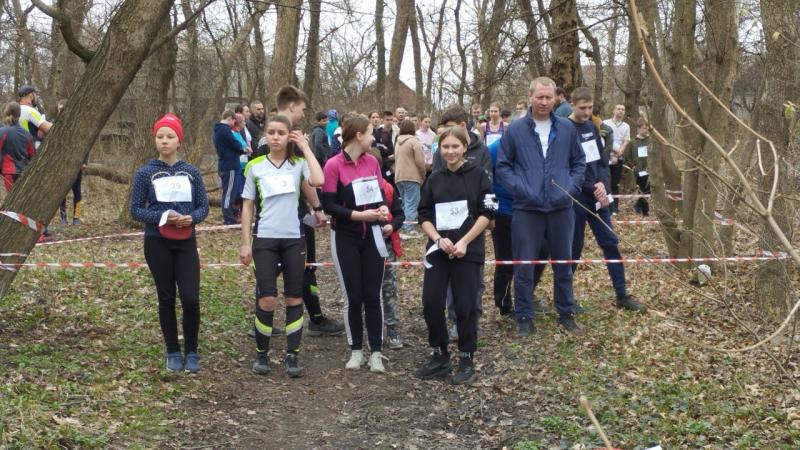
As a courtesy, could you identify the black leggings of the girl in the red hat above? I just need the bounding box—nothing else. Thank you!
[144,236,200,353]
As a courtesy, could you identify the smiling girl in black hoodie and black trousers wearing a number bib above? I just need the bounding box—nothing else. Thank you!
[416,127,496,384]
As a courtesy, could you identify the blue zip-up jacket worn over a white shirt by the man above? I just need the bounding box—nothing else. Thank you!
[495,109,586,213]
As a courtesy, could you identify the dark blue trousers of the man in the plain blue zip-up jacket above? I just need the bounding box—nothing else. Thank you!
[511,207,575,320]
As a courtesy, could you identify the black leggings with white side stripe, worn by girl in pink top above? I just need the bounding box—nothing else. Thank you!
[331,230,384,352]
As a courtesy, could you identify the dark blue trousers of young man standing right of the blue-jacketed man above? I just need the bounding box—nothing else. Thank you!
[572,193,625,297]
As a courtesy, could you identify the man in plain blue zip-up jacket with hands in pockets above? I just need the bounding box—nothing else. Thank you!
[495,77,586,337]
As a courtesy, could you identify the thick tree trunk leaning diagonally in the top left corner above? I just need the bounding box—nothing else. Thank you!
[0,0,177,298]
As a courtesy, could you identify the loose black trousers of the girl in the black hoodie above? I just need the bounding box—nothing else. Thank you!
[422,251,481,354]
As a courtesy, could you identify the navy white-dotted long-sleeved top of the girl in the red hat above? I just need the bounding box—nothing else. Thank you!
[131,159,209,236]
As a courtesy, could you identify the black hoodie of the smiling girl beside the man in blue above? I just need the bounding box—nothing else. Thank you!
[419,161,495,264]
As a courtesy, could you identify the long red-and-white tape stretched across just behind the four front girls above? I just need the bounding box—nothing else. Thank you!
[0,251,789,269]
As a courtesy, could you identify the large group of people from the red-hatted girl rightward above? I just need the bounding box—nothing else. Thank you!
[126,77,648,384]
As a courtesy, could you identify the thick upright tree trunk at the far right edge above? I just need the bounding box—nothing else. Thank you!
[748,0,800,317]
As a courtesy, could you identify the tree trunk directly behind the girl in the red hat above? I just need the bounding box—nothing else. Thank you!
[119,15,178,226]
